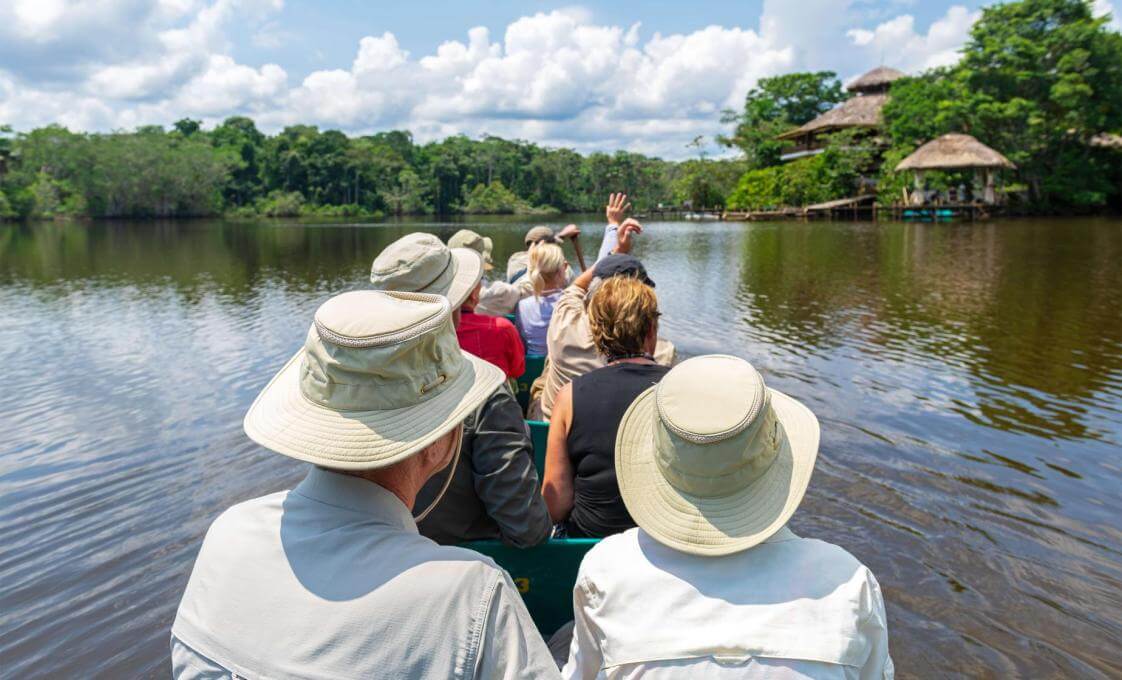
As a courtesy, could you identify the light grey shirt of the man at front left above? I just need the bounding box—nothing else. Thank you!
[172,468,558,679]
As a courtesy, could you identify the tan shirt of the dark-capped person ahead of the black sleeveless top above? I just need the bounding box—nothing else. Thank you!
[541,286,674,419]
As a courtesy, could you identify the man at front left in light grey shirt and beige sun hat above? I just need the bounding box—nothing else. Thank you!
[172,291,557,679]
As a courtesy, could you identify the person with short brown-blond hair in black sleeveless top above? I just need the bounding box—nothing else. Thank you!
[542,275,670,537]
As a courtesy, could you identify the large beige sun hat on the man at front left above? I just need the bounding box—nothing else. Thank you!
[251,291,505,469]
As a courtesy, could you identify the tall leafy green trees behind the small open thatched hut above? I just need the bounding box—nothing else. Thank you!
[881,0,1122,212]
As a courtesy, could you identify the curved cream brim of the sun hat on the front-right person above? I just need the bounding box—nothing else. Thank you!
[616,387,819,555]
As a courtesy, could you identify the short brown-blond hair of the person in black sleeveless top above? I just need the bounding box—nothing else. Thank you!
[588,276,659,357]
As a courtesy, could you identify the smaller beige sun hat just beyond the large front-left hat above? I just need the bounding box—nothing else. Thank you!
[370,232,484,310]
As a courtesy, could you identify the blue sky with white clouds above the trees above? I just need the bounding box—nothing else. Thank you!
[0,0,1119,158]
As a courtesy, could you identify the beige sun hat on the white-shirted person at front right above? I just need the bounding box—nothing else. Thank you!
[616,355,819,555]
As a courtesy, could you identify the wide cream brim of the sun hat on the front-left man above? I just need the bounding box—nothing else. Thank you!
[243,349,505,470]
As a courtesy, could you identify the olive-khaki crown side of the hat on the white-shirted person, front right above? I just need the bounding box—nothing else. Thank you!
[654,406,783,498]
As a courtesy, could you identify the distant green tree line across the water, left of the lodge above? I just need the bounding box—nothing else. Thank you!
[0,116,739,218]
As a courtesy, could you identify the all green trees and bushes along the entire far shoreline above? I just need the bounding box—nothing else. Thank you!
[0,0,1122,220]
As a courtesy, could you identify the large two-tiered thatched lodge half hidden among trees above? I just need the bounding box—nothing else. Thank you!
[779,66,904,160]
